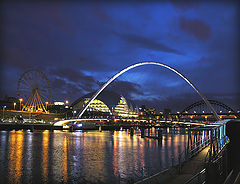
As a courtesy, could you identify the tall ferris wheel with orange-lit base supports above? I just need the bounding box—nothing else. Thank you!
[17,70,51,112]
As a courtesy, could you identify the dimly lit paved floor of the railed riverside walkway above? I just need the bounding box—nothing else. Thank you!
[136,147,209,184]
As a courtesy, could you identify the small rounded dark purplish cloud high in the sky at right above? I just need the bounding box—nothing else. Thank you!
[179,17,211,41]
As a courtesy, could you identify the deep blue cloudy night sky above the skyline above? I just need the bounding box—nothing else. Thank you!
[0,1,240,111]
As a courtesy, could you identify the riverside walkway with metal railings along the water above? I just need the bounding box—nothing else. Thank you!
[136,120,229,184]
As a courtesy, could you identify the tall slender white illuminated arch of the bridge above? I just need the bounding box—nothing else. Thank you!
[78,61,220,120]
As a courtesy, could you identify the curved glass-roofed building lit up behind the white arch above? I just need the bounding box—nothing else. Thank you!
[71,91,139,118]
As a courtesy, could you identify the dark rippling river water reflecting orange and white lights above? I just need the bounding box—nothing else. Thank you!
[0,130,187,183]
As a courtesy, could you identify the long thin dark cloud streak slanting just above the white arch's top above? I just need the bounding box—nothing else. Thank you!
[114,32,184,55]
